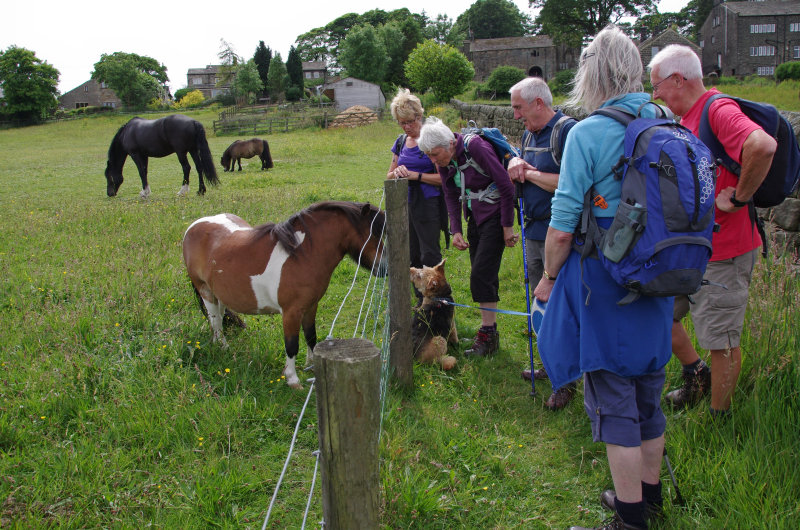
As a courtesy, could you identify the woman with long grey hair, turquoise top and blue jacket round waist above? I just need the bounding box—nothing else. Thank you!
[534,26,672,528]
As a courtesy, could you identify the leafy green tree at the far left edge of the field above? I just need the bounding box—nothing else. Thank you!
[0,46,59,122]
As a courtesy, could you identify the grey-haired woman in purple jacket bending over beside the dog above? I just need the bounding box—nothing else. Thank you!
[418,117,518,357]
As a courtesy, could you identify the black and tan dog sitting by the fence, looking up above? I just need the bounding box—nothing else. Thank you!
[411,260,458,370]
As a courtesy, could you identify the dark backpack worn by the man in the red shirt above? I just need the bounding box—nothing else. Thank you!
[698,94,800,208]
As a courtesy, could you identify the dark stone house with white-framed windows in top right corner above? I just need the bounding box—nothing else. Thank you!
[700,0,800,76]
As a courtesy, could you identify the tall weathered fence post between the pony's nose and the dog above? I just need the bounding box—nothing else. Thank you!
[383,179,414,387]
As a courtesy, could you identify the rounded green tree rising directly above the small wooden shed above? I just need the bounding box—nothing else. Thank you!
[339,24,389,83]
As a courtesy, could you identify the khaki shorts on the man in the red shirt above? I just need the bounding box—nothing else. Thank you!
[672,249,760,350]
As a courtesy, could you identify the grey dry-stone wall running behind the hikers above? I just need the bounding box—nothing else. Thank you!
[451,100,800,260]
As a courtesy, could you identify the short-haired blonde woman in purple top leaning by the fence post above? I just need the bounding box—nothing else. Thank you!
[386,88,442,278]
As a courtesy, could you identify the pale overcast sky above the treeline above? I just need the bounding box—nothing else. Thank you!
[0,0,688,93]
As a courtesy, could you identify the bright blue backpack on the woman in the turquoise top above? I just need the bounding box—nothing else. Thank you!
[576,102,716,305]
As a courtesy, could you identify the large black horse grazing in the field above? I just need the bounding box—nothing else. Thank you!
[106,114,219,197]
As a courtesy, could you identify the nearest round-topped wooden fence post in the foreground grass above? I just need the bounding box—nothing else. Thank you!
[314,339,381,530]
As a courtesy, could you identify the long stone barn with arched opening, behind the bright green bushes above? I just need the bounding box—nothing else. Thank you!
[461,35,581,82]
